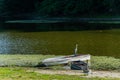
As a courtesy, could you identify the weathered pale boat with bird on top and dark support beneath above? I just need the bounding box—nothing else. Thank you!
[42,45,90,73]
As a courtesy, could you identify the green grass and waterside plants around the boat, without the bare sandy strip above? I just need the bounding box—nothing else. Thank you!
[0,55,120,80]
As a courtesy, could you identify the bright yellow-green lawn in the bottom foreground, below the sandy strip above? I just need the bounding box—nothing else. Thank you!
[0,67,118,80]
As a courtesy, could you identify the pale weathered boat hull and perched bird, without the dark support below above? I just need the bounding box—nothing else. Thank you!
[42,44,90,66]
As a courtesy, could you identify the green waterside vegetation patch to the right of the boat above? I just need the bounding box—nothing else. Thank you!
[91,56,120,71]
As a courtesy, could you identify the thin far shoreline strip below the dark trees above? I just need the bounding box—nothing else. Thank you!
[5,17,120,24]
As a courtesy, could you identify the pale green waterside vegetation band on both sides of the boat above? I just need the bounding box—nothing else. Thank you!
[0,55,120,71]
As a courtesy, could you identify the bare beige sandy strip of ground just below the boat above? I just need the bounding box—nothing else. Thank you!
[29,69,120,78]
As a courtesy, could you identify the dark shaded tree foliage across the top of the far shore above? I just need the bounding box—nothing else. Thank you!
[0,0,120,19]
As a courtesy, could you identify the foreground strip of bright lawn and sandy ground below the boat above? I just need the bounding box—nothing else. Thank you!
[0,67,120,80]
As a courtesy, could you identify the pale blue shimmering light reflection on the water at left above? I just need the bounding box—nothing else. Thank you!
[0,32,42,54]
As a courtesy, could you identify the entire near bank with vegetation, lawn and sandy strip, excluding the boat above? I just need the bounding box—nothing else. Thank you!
[0,54,120,80]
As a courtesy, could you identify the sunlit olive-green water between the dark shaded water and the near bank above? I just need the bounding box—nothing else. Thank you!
[0,30,120,57]
